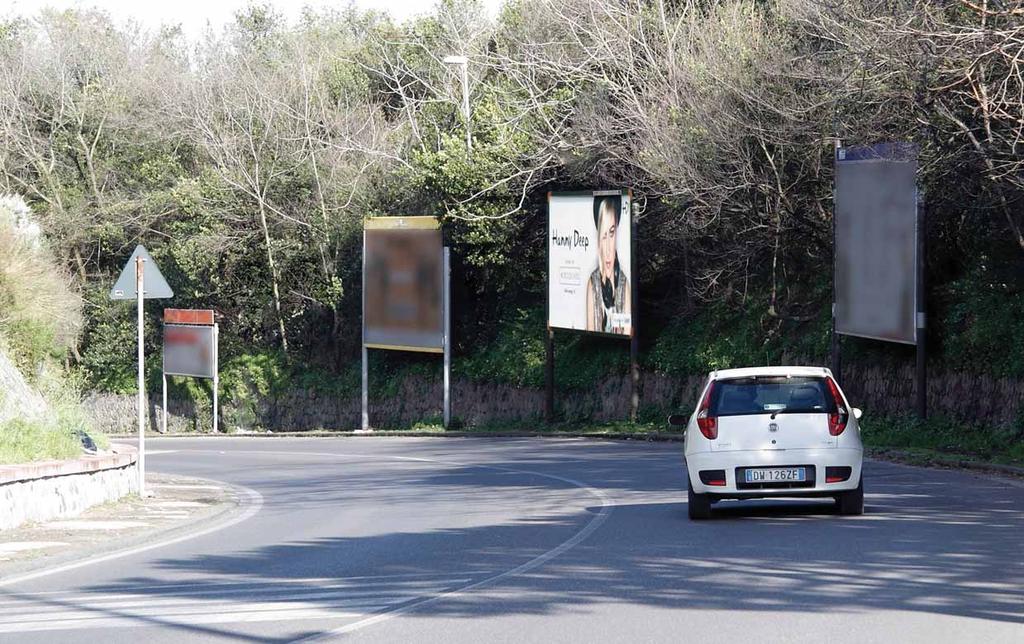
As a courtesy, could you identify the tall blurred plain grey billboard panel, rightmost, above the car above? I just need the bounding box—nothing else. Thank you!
[835,144,918,344]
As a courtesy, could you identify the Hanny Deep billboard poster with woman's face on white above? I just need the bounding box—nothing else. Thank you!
[548,190,633,337]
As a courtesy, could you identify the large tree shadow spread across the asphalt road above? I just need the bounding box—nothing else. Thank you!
[12,444,1024,639]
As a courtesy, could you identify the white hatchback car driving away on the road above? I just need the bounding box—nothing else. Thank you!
[669,367,864,519]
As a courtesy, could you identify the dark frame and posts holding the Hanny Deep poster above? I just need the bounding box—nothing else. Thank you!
[544,188,640,424]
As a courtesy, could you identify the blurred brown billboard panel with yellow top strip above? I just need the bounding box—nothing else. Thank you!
[362,217,444,352]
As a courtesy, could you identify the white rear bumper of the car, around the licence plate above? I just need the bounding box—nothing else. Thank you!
[686,447,863,499]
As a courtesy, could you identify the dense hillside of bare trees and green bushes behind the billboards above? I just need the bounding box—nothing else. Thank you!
[0,0,1024,430]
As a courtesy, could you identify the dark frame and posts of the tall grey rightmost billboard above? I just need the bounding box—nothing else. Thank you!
[831,138,928,420]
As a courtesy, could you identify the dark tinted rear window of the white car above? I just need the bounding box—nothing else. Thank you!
[710,376,836,416]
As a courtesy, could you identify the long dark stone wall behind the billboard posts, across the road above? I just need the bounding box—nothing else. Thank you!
[86,366,1024,433]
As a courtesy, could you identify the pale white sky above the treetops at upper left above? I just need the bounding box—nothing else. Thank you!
[7,0,501,38]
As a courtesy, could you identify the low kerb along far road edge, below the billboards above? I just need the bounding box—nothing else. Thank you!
[112,430,1024,478]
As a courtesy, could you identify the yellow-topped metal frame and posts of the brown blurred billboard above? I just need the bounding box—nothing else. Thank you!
[359,215,452,432]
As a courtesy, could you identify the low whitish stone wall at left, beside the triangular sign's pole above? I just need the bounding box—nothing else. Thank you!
[0,445,138,530]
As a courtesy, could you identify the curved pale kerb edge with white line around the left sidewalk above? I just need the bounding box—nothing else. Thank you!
[0,473,252,588]
